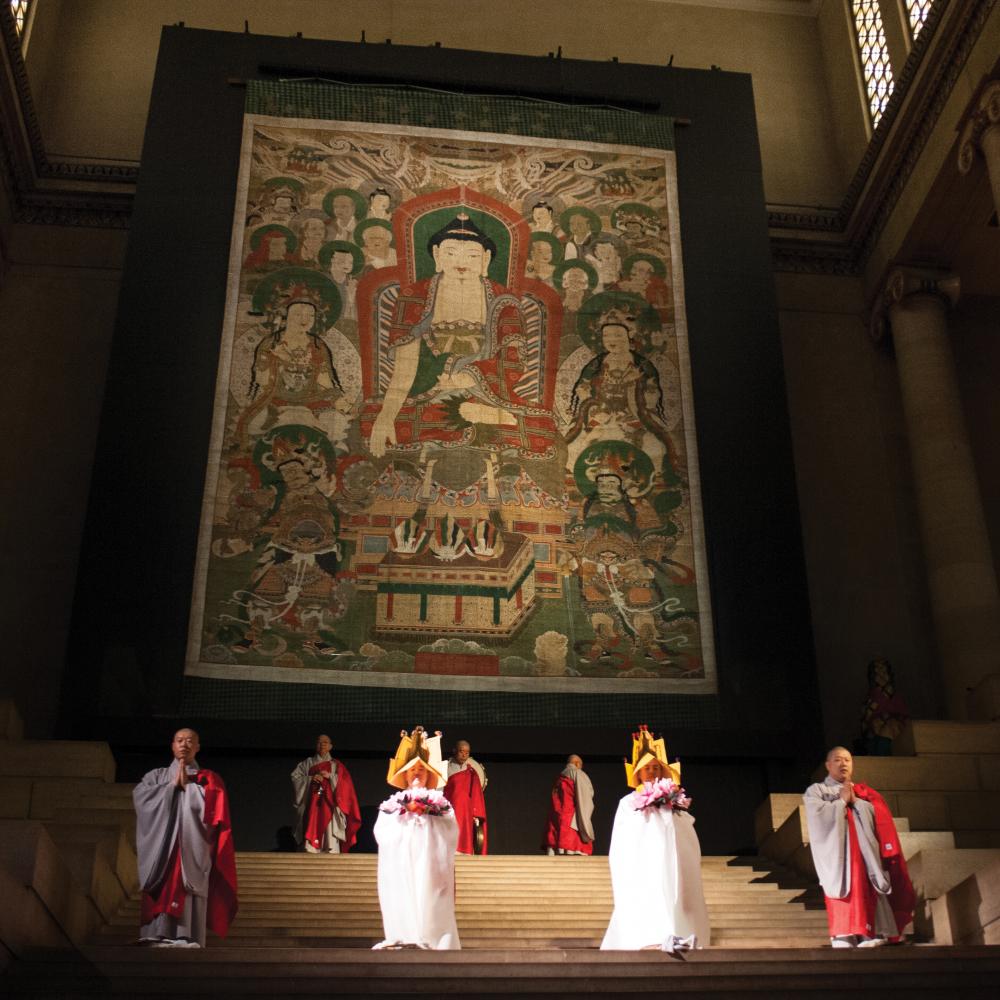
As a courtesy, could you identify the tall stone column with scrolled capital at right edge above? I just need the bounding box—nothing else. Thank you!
[874,267,1000,719]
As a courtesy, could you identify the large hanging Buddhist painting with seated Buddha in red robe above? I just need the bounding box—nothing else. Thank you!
[187,97,715,693]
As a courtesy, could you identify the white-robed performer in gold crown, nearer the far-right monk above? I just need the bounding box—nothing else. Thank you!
[601,726,710,952]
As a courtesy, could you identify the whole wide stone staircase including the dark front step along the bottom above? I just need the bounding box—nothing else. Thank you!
[0,853,1000,1000]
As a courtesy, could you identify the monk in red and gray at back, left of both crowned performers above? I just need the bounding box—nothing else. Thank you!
[292,733,361,854]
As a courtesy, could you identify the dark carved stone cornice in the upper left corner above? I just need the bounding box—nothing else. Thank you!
[0,3,139,229]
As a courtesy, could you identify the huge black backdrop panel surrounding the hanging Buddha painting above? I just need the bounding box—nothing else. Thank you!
[62,27,819,753]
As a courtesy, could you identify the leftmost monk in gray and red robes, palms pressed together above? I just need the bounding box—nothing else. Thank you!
[132,729,237,948]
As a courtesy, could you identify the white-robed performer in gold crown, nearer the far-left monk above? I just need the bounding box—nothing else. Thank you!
[375,726,461,951]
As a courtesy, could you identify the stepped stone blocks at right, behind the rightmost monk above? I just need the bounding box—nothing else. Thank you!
[756,720,1000,943]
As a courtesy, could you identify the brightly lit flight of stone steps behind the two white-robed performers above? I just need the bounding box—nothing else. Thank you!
[94,853,827,949]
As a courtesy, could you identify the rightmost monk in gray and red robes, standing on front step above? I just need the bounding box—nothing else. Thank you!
[804,747,915,948]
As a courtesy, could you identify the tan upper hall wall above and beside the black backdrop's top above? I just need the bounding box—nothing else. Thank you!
[27,0,863,206]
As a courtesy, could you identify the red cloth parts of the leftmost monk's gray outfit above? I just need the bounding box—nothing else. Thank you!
[142,769,239,937]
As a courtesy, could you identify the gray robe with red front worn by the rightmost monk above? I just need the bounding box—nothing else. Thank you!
[803,776,899,937]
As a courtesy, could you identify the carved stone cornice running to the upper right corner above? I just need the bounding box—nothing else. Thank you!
[768,0,997,274]
